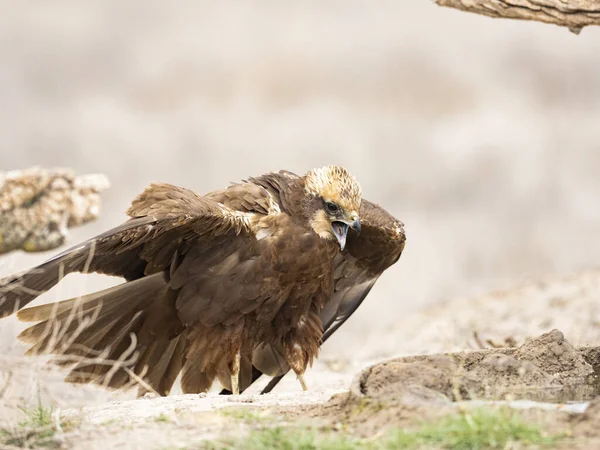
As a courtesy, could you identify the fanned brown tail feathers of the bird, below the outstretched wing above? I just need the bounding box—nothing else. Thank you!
[18,273,187,395]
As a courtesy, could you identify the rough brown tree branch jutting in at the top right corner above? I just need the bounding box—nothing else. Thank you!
[433,0,600,34]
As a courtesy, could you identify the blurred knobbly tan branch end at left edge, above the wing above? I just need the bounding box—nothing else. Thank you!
[0,167,109,254]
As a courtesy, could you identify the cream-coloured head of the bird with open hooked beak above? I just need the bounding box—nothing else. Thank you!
[305,166,362,250]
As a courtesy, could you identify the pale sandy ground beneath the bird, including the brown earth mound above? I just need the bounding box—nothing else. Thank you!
[3,271,600,449]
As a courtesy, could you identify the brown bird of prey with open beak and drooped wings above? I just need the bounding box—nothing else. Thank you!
[0,166,405,395]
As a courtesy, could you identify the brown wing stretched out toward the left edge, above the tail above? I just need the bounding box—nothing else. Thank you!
[0,184,250,318]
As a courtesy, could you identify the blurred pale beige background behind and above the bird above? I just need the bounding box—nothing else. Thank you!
[0,0,600,414]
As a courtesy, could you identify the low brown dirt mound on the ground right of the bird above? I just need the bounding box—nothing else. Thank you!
[350,330,596,404]
